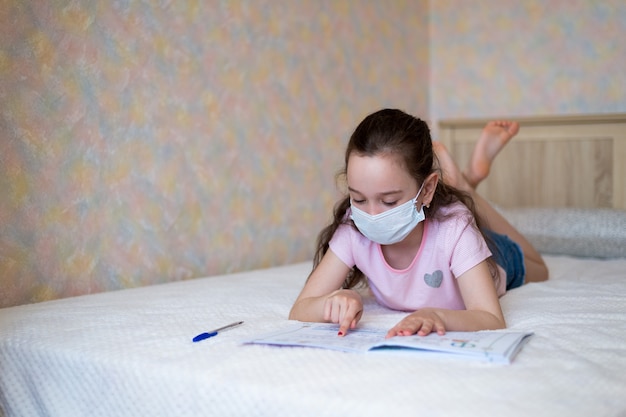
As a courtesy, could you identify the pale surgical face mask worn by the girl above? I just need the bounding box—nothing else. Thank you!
[350,184,425,245]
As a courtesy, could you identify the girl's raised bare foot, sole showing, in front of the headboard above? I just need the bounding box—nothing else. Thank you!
[463,120,519,188]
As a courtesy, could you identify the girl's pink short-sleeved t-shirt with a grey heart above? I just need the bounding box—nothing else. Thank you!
[330,203,506,311]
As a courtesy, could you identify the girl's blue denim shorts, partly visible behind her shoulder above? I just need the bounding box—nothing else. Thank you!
[483,229,526,291]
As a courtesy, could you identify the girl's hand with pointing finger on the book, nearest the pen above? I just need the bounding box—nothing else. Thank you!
[324,289,363,336]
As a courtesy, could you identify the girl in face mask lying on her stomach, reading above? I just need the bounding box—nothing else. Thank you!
[289,109,548,337]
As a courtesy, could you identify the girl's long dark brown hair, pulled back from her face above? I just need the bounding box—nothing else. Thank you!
[313,109,497,288]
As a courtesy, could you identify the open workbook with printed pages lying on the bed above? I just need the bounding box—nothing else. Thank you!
[245,323,533,363]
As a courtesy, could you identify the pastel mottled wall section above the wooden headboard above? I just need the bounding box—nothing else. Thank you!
[429,0,626,120]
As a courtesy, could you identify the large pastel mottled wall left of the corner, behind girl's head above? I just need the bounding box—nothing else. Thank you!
[0,0,428,306]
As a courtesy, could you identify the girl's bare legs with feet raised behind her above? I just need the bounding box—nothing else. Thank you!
[433,122,548,282]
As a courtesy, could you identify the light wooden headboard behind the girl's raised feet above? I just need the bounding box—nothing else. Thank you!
[439,114,626,209]
